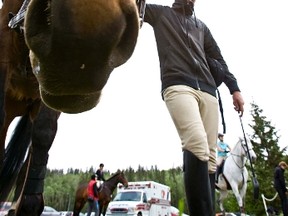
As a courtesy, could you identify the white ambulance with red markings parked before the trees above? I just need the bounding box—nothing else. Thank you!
[106,181,171,216]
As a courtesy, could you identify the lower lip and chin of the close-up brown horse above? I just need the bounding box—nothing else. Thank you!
[40,88,101,114]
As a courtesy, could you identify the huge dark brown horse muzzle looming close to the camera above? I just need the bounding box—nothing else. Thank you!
[24,0,139,113]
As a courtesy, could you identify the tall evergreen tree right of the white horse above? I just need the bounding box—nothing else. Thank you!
[245,103,286,215]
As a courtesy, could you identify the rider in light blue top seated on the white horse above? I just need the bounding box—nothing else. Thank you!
[215,133,231,183]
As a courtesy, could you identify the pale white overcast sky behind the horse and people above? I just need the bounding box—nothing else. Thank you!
[2,0,288,172]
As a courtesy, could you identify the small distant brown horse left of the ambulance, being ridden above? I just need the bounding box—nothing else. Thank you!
[73,171,128,216]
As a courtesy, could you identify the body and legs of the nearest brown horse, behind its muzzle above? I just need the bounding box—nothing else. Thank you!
[0,0,60,216]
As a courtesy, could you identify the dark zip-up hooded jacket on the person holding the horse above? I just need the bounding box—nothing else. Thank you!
[144,0,240,97]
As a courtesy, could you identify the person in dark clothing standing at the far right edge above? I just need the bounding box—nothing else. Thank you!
[274,161,288,216]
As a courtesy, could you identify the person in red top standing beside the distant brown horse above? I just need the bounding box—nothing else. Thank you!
[87,174,99,216]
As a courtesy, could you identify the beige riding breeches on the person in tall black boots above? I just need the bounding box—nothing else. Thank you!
[163,85,218,173]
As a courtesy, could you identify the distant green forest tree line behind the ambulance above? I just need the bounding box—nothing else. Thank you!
[44,165,184,212]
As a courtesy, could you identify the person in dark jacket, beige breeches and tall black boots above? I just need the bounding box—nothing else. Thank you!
[141,0,244,216]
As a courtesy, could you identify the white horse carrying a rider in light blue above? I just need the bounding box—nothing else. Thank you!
[216,138,256,215]
